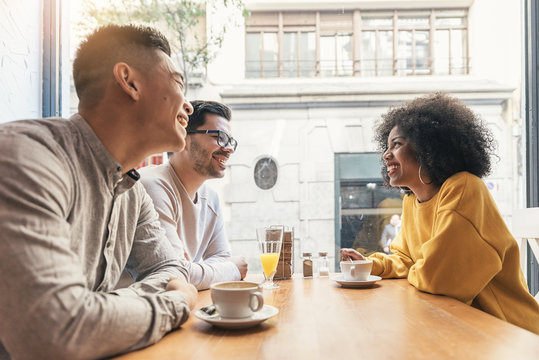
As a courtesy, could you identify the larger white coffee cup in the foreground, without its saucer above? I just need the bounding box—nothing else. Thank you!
[210,281,264,318]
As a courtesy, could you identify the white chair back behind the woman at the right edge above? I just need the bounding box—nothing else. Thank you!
[512,208,539,301]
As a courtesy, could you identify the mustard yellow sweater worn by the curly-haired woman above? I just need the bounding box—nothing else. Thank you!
[370,172,539,334]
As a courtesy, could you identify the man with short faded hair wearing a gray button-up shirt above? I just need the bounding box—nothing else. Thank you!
[0,26,196,359]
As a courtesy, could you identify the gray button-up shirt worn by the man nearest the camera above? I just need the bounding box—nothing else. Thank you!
[0,115,189,359]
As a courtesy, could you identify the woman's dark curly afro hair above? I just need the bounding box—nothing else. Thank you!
[375,93,496,193]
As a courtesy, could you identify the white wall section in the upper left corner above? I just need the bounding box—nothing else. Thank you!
[0,0,43,123]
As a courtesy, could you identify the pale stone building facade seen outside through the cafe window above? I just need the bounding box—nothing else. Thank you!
[189,0,525,270]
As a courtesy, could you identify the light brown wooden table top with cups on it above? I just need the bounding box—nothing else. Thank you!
[115,277,539,360]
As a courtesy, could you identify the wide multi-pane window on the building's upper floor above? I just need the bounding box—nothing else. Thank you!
[245,9,470,78]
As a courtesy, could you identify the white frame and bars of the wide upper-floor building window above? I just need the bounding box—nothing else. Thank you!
[245,8,470,78]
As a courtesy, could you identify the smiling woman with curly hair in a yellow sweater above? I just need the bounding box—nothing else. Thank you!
[341,93,539,334]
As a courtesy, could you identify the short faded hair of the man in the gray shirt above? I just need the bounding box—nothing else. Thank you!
[73,25,171,106]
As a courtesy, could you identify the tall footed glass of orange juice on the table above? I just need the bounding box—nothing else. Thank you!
[256,226,284,289]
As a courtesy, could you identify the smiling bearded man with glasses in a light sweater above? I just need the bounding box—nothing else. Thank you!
[141,101,247,290]
